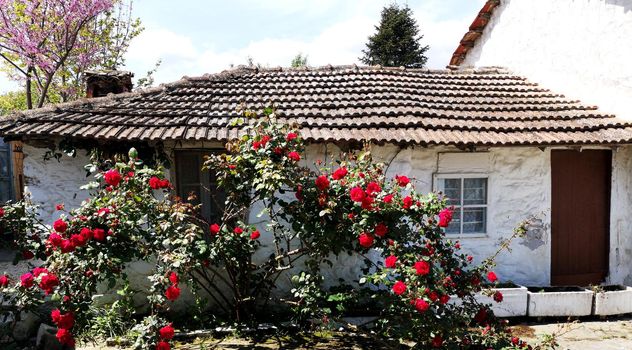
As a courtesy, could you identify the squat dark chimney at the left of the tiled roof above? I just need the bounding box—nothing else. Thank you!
[85,70,134,98]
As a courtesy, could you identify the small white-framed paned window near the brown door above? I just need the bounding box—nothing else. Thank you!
[436,175,487,235]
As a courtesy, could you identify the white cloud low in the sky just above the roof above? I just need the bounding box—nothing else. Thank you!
[127,4,476,83]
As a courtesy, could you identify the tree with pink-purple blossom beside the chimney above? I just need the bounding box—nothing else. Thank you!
[0,0,142,109]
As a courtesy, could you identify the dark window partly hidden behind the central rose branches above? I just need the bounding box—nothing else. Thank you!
[176,150,226,222]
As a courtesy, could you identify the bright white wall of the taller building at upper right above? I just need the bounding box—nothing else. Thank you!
[462,0,632,119]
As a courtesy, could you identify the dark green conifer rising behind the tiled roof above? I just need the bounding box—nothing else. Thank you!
[360,4,428,68]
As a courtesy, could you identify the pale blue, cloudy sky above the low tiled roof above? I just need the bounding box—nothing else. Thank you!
[0,0,485,92]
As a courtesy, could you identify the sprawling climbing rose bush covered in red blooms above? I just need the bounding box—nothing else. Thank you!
[0,109,526,349]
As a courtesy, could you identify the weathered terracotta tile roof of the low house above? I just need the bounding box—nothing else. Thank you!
[0,66,632,146]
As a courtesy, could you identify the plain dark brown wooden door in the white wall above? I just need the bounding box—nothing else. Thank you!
[551,150,612,286]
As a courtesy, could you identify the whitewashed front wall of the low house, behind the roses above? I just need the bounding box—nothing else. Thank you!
[18,144,632,288]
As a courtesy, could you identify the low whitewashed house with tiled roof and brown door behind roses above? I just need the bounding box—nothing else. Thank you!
[0,66,632,285]
